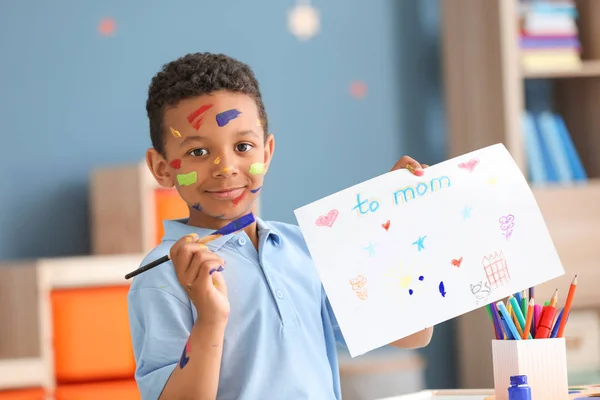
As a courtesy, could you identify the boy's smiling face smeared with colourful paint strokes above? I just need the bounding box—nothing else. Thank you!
[146,92,274,229]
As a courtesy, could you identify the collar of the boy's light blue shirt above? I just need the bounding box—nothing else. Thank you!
[163,218,281,251]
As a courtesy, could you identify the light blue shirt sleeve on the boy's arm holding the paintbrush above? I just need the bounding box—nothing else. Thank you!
[128,288,193,400]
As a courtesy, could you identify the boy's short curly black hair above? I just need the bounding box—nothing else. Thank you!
[146,53,269,156]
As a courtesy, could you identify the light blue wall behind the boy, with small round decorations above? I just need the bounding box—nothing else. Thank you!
[0,0,453,386]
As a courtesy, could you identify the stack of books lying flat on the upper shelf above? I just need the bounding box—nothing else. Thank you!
[519,0,581,70]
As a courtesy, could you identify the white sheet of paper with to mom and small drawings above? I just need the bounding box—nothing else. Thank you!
[294,144,564,357]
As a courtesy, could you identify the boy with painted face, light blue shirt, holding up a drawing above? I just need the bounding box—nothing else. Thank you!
[128,53,432,400]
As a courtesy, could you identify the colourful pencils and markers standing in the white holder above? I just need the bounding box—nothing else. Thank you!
[486,275,577,340]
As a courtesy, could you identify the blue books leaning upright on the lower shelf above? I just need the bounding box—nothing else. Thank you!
[522,111,587,185]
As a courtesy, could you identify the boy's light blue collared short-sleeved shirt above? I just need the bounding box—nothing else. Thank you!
[128,219,343,400]
